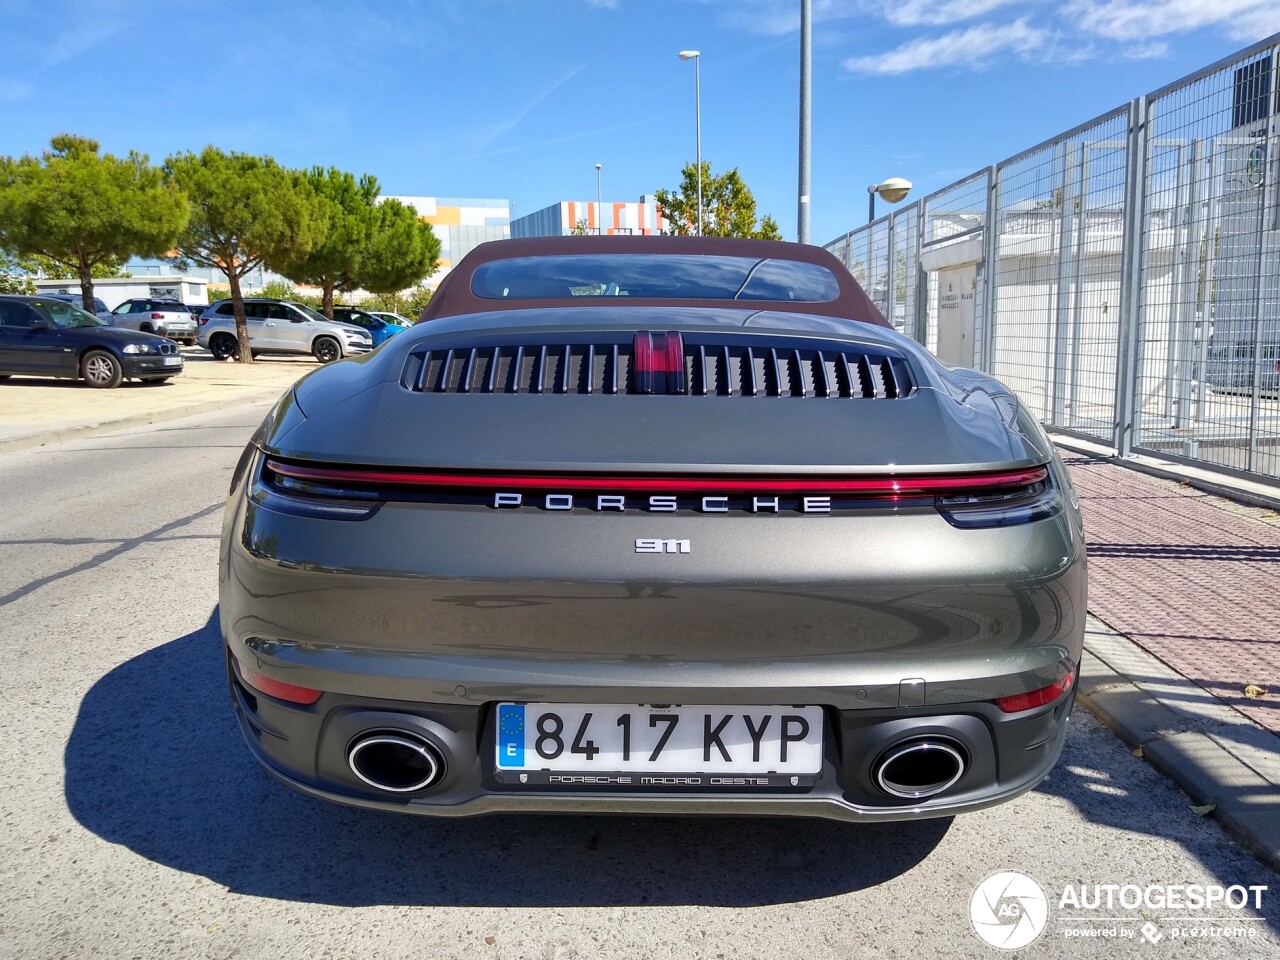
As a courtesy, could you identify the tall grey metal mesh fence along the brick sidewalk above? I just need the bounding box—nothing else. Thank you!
[827,35,1280,480]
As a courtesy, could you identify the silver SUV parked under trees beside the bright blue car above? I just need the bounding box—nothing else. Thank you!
[200,300,374,364]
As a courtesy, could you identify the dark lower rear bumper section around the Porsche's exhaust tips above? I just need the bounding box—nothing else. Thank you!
[228,657,1074,820]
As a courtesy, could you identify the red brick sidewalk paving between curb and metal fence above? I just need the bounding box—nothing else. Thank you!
[1065,456,1280,732]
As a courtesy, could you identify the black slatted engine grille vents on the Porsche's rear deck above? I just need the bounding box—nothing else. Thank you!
[401,335,915,399]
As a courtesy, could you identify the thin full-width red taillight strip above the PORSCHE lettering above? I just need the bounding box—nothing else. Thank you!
[266,460,1048,497]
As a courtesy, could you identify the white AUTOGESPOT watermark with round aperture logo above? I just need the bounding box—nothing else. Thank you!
[969,870,1267,950]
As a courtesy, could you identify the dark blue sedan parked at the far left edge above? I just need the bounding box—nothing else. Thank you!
[0,296,182,387]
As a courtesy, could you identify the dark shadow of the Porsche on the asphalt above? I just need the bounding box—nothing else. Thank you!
[65,611,951,906]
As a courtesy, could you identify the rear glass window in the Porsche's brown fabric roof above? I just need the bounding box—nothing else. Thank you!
[471,253,840,303]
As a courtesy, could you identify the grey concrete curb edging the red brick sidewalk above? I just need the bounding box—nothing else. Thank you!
[1076,617,1280,872]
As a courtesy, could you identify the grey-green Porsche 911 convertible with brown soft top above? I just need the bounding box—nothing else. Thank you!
[219,237,1085,820]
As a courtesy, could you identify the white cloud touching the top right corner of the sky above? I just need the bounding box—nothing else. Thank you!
[1062,0,1280,41]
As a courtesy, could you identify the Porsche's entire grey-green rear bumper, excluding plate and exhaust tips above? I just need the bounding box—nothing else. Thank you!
[220,448,1085,820]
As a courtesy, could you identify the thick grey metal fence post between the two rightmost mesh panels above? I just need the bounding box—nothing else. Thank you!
[1112,96,1149,457]
